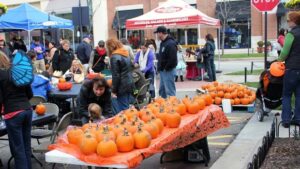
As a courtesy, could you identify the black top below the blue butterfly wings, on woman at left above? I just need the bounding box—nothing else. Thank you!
[0,76,33,114]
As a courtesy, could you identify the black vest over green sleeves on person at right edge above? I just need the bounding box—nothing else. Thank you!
[285,26,300,69]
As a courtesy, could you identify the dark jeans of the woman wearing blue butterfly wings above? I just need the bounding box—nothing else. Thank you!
[5,110,32,169]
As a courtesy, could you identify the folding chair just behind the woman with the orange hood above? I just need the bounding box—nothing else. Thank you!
[134,79,151,109]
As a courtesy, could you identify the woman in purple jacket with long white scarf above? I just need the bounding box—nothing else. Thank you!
[134,43,155,98]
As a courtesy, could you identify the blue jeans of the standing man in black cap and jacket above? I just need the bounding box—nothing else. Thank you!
[159,68,176,98]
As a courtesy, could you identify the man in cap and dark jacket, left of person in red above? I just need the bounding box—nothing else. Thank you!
[76,35,92,64]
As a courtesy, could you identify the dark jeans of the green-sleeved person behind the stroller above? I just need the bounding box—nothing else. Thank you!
[281,69,300,123]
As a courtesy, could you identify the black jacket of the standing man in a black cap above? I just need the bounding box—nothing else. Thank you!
[157,35,177,71]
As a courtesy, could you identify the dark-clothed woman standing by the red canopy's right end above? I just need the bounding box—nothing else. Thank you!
[201,34,216,81]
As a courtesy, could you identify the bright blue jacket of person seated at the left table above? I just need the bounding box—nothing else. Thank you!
[31,75,52,99]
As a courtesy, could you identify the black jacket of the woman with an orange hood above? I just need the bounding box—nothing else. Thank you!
[110,50,134,96]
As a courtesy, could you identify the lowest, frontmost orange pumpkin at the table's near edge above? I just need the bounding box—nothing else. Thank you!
[97,137,118,157]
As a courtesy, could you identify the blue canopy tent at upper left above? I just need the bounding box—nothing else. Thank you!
[0,3,74,47]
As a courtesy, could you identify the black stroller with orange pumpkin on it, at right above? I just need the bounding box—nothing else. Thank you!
[255,70,283,122]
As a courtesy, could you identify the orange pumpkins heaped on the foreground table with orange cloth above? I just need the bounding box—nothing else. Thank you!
[67,94,213,157]
